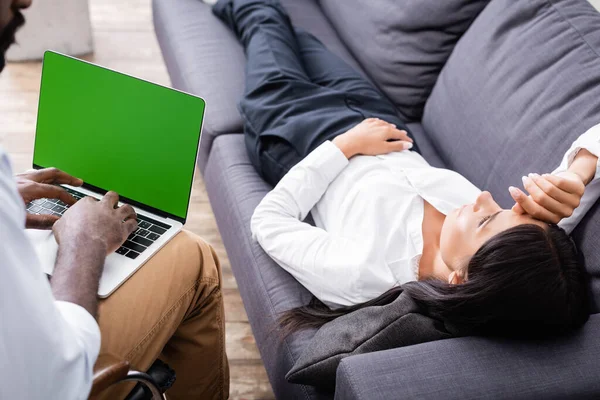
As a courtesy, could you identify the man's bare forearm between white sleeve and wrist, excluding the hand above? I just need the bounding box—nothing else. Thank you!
[50,243,106,317]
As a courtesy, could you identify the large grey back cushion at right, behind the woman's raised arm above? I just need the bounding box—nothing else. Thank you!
[423,0,600,311]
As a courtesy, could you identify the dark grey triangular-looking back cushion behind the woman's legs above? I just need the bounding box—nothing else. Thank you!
[320,0,489,121]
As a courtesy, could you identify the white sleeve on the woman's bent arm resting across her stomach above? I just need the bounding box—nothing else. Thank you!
[251,141,372,304]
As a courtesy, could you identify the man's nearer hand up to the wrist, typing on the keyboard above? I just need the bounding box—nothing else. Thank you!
[52,192,137,255]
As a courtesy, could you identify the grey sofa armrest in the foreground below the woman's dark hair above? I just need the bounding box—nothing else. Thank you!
[335,314,600,400]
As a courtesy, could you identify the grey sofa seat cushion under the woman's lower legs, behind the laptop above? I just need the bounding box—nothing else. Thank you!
[153,0,368,171]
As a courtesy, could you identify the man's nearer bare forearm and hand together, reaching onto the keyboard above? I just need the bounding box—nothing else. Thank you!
[50,192,137,316]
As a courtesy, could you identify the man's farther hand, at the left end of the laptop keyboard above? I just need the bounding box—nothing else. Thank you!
[15,168,83,229]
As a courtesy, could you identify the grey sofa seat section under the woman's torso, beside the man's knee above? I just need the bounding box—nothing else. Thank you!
[204,134,330,399]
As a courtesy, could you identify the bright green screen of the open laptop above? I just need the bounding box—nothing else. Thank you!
[33,52,205,219]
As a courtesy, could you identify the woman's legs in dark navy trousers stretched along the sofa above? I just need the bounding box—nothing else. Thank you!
[213,0,414,185]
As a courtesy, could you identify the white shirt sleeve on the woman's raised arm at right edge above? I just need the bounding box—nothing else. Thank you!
[552,124,600,233]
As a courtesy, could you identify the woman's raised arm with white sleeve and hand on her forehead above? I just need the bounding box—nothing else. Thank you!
[509,124,600,233]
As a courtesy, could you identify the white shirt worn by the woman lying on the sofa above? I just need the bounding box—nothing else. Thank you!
[251,125,600,307]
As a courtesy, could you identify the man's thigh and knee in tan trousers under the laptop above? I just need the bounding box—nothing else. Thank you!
[99,231,220,396]
